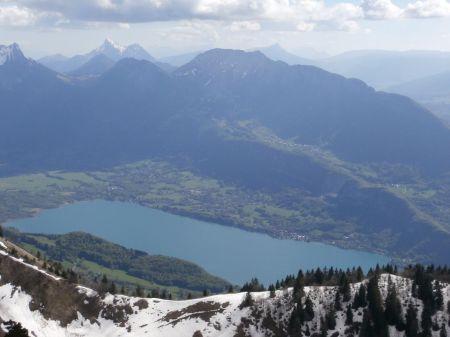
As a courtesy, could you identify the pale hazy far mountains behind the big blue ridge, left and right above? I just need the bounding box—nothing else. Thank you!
[38,39,450,90]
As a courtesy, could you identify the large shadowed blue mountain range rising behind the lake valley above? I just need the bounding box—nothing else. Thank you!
[0,46,450,263]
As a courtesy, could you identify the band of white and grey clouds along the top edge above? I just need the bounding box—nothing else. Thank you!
[0,0,450,32]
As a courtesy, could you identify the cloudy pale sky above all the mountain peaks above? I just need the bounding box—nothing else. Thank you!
[0,0,450,57]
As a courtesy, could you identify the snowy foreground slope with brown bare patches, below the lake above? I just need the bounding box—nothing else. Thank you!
[0,243,450,337]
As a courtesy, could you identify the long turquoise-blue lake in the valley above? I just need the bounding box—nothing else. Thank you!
[6,200,390,285]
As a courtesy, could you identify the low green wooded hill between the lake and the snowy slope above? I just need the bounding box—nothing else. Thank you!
[7,230,229,297]
